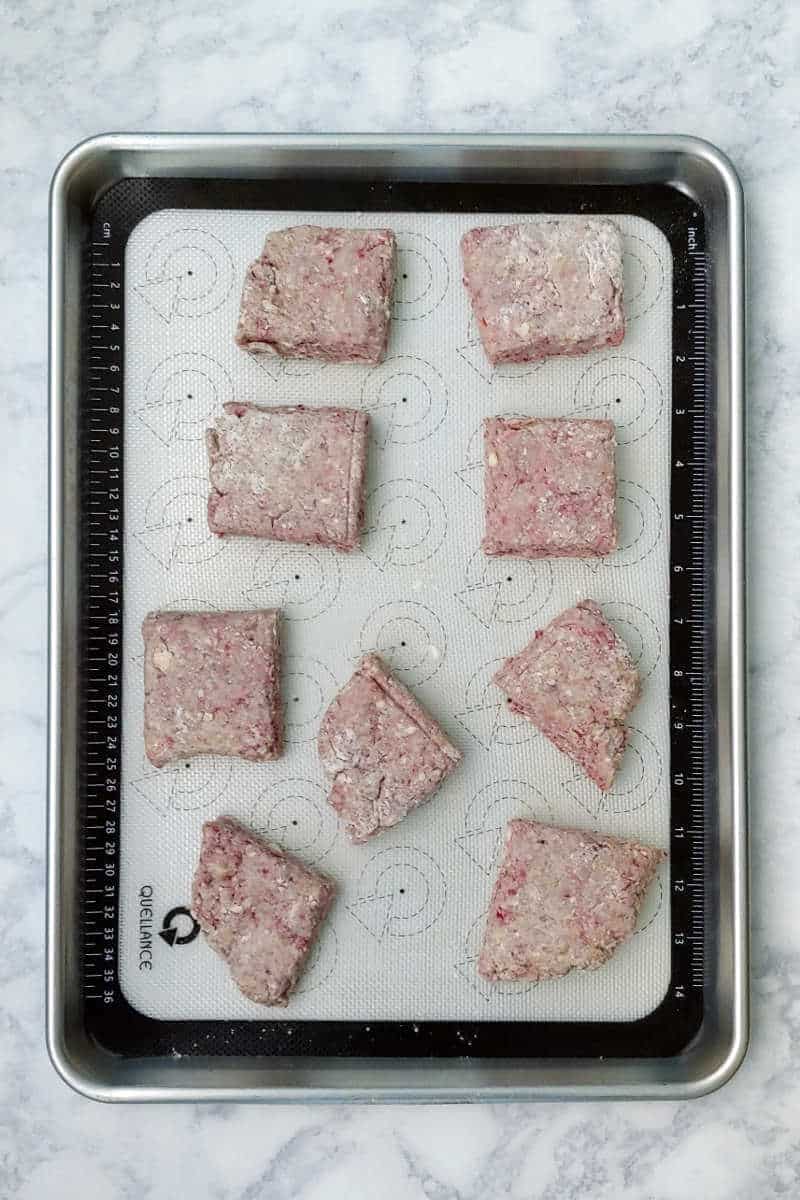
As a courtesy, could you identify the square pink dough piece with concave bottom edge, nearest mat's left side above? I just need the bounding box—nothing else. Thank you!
[142,608,283,767]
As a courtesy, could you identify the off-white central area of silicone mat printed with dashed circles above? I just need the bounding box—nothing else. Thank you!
[120,210,672,1021]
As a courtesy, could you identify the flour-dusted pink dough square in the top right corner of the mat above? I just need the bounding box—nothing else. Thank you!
[461,216,625,364]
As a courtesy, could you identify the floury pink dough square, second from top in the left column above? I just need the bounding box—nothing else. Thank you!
[206,403,369,550]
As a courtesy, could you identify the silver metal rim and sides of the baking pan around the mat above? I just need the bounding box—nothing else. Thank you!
[50,138,745,1097]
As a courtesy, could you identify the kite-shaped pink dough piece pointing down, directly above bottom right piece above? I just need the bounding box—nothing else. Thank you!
[494,600,639,792]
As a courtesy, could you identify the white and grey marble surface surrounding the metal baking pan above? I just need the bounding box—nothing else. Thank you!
[0,0,800,1200]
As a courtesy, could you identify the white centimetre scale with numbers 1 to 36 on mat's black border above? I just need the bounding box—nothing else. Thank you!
[80,221,124,1007]
